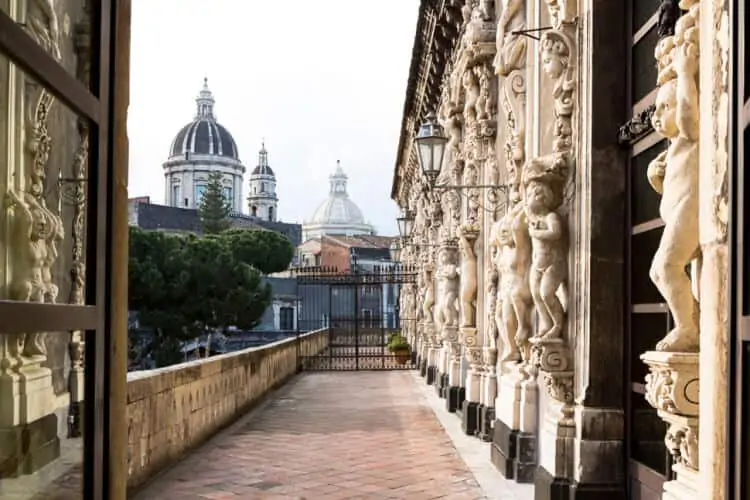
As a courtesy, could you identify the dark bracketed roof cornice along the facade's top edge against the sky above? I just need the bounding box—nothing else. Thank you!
[391,0,464,205]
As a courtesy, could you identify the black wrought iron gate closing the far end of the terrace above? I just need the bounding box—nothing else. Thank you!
[295,265,424,371]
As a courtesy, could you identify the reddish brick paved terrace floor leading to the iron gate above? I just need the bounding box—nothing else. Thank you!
[137,372,484,500]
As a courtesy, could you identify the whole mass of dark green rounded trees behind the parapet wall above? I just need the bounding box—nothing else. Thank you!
[129,227,294,363]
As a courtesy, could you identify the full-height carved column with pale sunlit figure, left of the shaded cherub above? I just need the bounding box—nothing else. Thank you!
[490,0,537,482]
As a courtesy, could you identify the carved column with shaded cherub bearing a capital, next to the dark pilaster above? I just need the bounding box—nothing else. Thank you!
[520,1,587,495]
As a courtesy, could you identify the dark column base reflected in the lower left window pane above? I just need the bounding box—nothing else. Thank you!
[0,414,60,478]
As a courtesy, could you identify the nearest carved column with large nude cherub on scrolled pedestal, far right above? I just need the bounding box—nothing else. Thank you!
[641,0,704,500]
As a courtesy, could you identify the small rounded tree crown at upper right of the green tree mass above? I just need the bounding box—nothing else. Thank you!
[222,229,294,274]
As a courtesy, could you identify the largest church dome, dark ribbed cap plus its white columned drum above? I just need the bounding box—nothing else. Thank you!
[162,79,245,212]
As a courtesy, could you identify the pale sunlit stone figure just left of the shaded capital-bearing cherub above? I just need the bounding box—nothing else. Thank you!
[492,191,532,362]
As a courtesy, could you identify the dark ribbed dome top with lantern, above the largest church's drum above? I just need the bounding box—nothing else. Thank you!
[169,79,239,160]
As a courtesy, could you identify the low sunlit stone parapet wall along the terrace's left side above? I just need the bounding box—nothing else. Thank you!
[128,330,328,489]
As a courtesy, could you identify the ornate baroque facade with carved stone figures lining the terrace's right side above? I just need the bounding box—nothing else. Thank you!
[392,0,742,499]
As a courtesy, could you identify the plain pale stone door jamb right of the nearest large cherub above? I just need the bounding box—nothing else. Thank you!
[698,1,728,500]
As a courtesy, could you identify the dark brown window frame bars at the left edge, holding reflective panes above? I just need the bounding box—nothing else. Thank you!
[0,0,116,500]
